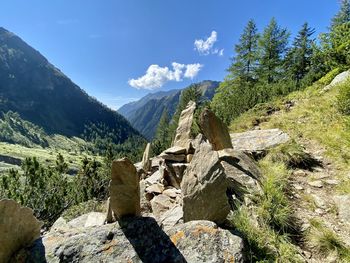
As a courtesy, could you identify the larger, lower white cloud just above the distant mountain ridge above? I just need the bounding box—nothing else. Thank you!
[128,62,203,90]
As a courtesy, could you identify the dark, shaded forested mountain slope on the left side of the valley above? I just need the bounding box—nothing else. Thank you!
[0,27,139,142]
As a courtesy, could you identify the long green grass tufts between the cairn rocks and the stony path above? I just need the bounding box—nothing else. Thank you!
[231,156,303,262]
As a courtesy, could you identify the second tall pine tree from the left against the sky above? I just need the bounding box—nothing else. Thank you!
[258,18,290,84]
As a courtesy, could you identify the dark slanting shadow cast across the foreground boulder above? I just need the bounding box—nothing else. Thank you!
[118,217,187,263]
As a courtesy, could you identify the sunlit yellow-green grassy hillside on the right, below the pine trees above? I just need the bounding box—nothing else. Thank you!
[230,76,350,262]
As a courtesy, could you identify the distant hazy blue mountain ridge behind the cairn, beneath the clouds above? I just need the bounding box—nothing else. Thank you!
[118,80,220,139]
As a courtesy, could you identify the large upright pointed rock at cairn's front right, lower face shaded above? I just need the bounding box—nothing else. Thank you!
[181,143,230,223]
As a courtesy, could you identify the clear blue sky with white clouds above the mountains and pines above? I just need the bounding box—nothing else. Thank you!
[0,0,339,109]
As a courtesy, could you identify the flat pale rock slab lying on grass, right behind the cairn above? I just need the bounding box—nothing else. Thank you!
[230,129,290,153]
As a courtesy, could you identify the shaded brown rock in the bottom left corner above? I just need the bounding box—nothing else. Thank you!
[0,199,43,262]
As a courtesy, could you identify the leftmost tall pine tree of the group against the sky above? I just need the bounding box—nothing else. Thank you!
[228,19,259,82]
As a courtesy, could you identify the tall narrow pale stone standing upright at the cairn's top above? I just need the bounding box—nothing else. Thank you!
[172,101,196,148]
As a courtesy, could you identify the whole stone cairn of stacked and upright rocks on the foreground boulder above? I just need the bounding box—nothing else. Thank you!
[107,101,261,228]
